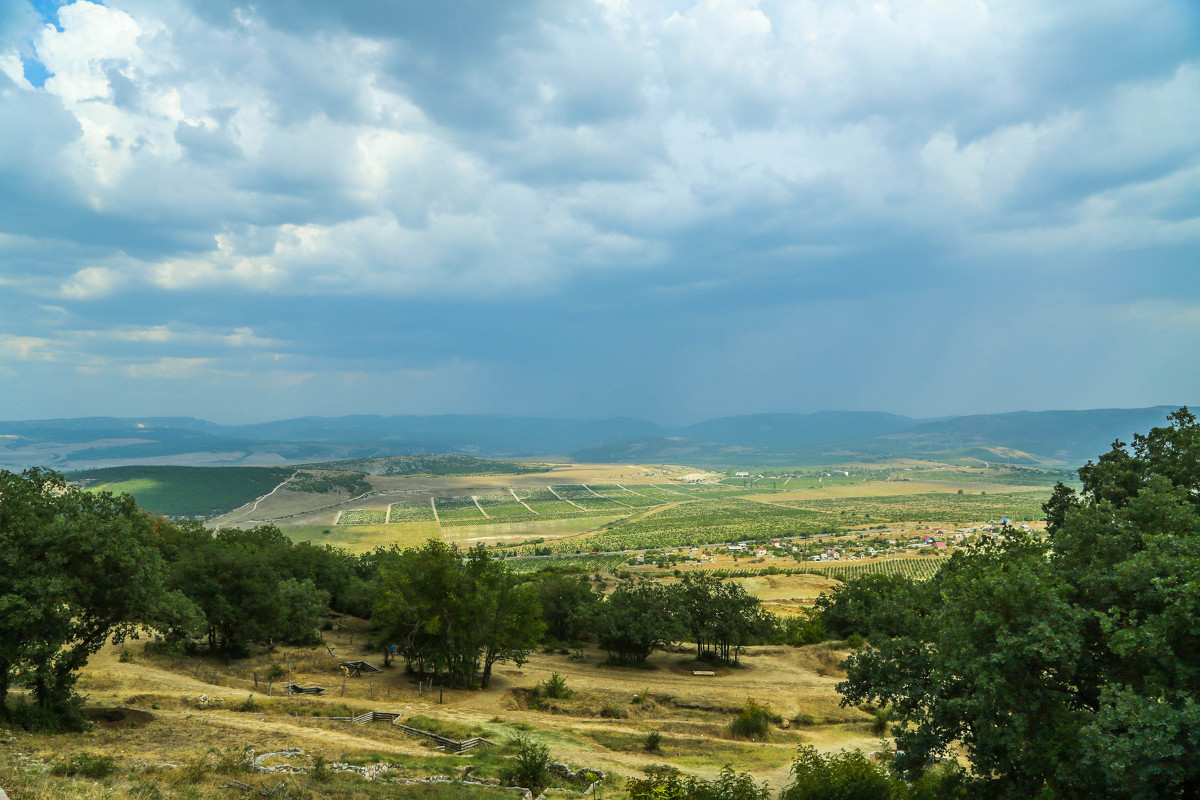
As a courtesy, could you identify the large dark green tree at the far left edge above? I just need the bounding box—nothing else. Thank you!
[0,469,179,716]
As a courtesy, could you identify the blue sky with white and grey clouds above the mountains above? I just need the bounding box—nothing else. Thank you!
[0,0,1200,425]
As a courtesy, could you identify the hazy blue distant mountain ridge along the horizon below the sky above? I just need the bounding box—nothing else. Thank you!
[0,405,1176,469]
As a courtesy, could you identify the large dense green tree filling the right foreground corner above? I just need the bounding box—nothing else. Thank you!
[839,409,1200,800]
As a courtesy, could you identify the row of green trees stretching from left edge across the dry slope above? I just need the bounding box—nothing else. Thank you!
[0,469,787,724]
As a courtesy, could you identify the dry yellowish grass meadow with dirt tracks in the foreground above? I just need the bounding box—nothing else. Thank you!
[0,585,880,800]
